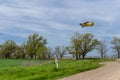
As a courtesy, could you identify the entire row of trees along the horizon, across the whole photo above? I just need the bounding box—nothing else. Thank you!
[0,33,120,59]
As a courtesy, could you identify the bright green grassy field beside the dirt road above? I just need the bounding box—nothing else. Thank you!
[0,59,113,80]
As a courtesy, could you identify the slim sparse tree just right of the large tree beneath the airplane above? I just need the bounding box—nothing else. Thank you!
[96,41,107,58]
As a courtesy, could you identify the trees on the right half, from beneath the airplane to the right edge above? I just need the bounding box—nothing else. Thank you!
[69,33,120,59]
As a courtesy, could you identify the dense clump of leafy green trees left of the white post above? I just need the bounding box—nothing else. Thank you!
[0,33,50,59]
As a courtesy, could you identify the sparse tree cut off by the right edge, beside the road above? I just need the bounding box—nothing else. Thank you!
[111,37,120,58]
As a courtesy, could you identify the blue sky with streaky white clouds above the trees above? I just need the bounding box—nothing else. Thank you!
[0,0,120,47]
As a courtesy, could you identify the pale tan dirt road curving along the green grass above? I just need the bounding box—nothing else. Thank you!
[59,60,120,80]
